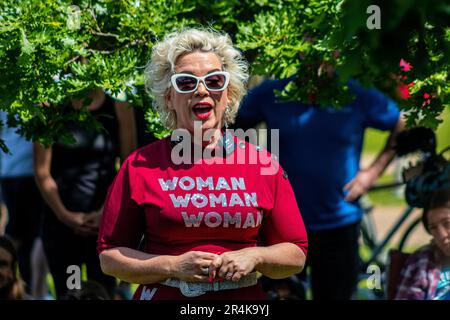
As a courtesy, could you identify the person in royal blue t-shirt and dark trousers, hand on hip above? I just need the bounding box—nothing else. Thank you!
[235,79,405,300]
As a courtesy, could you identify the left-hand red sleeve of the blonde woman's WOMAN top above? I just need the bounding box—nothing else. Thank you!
[97,156,145,253]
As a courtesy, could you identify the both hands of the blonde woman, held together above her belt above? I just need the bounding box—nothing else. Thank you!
[173,247,261,282]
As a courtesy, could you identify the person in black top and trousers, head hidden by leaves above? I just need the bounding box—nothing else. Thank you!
[34,89,136,298]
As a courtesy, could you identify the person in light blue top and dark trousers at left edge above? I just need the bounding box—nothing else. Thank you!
[0,111,47,297]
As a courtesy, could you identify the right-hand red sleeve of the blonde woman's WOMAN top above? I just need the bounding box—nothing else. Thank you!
[261,166,308,256]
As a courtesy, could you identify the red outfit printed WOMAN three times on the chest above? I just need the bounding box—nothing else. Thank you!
[98,137,307,300]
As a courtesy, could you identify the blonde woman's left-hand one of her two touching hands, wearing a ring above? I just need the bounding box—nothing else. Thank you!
[172,251,219,282]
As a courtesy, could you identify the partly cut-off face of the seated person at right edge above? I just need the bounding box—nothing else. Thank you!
[428,207,450,257]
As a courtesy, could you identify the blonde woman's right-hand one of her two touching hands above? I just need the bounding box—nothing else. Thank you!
[209,248,261,281]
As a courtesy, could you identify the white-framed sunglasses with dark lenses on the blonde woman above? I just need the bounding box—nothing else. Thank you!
[170,71,230,93]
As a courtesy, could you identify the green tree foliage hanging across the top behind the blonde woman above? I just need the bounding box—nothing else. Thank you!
[0,0,450,150]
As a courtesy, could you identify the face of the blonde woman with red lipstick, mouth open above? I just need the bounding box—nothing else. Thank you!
[166,51,229,133]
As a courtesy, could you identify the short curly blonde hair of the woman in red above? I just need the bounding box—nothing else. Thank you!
[145,28,249,129]
